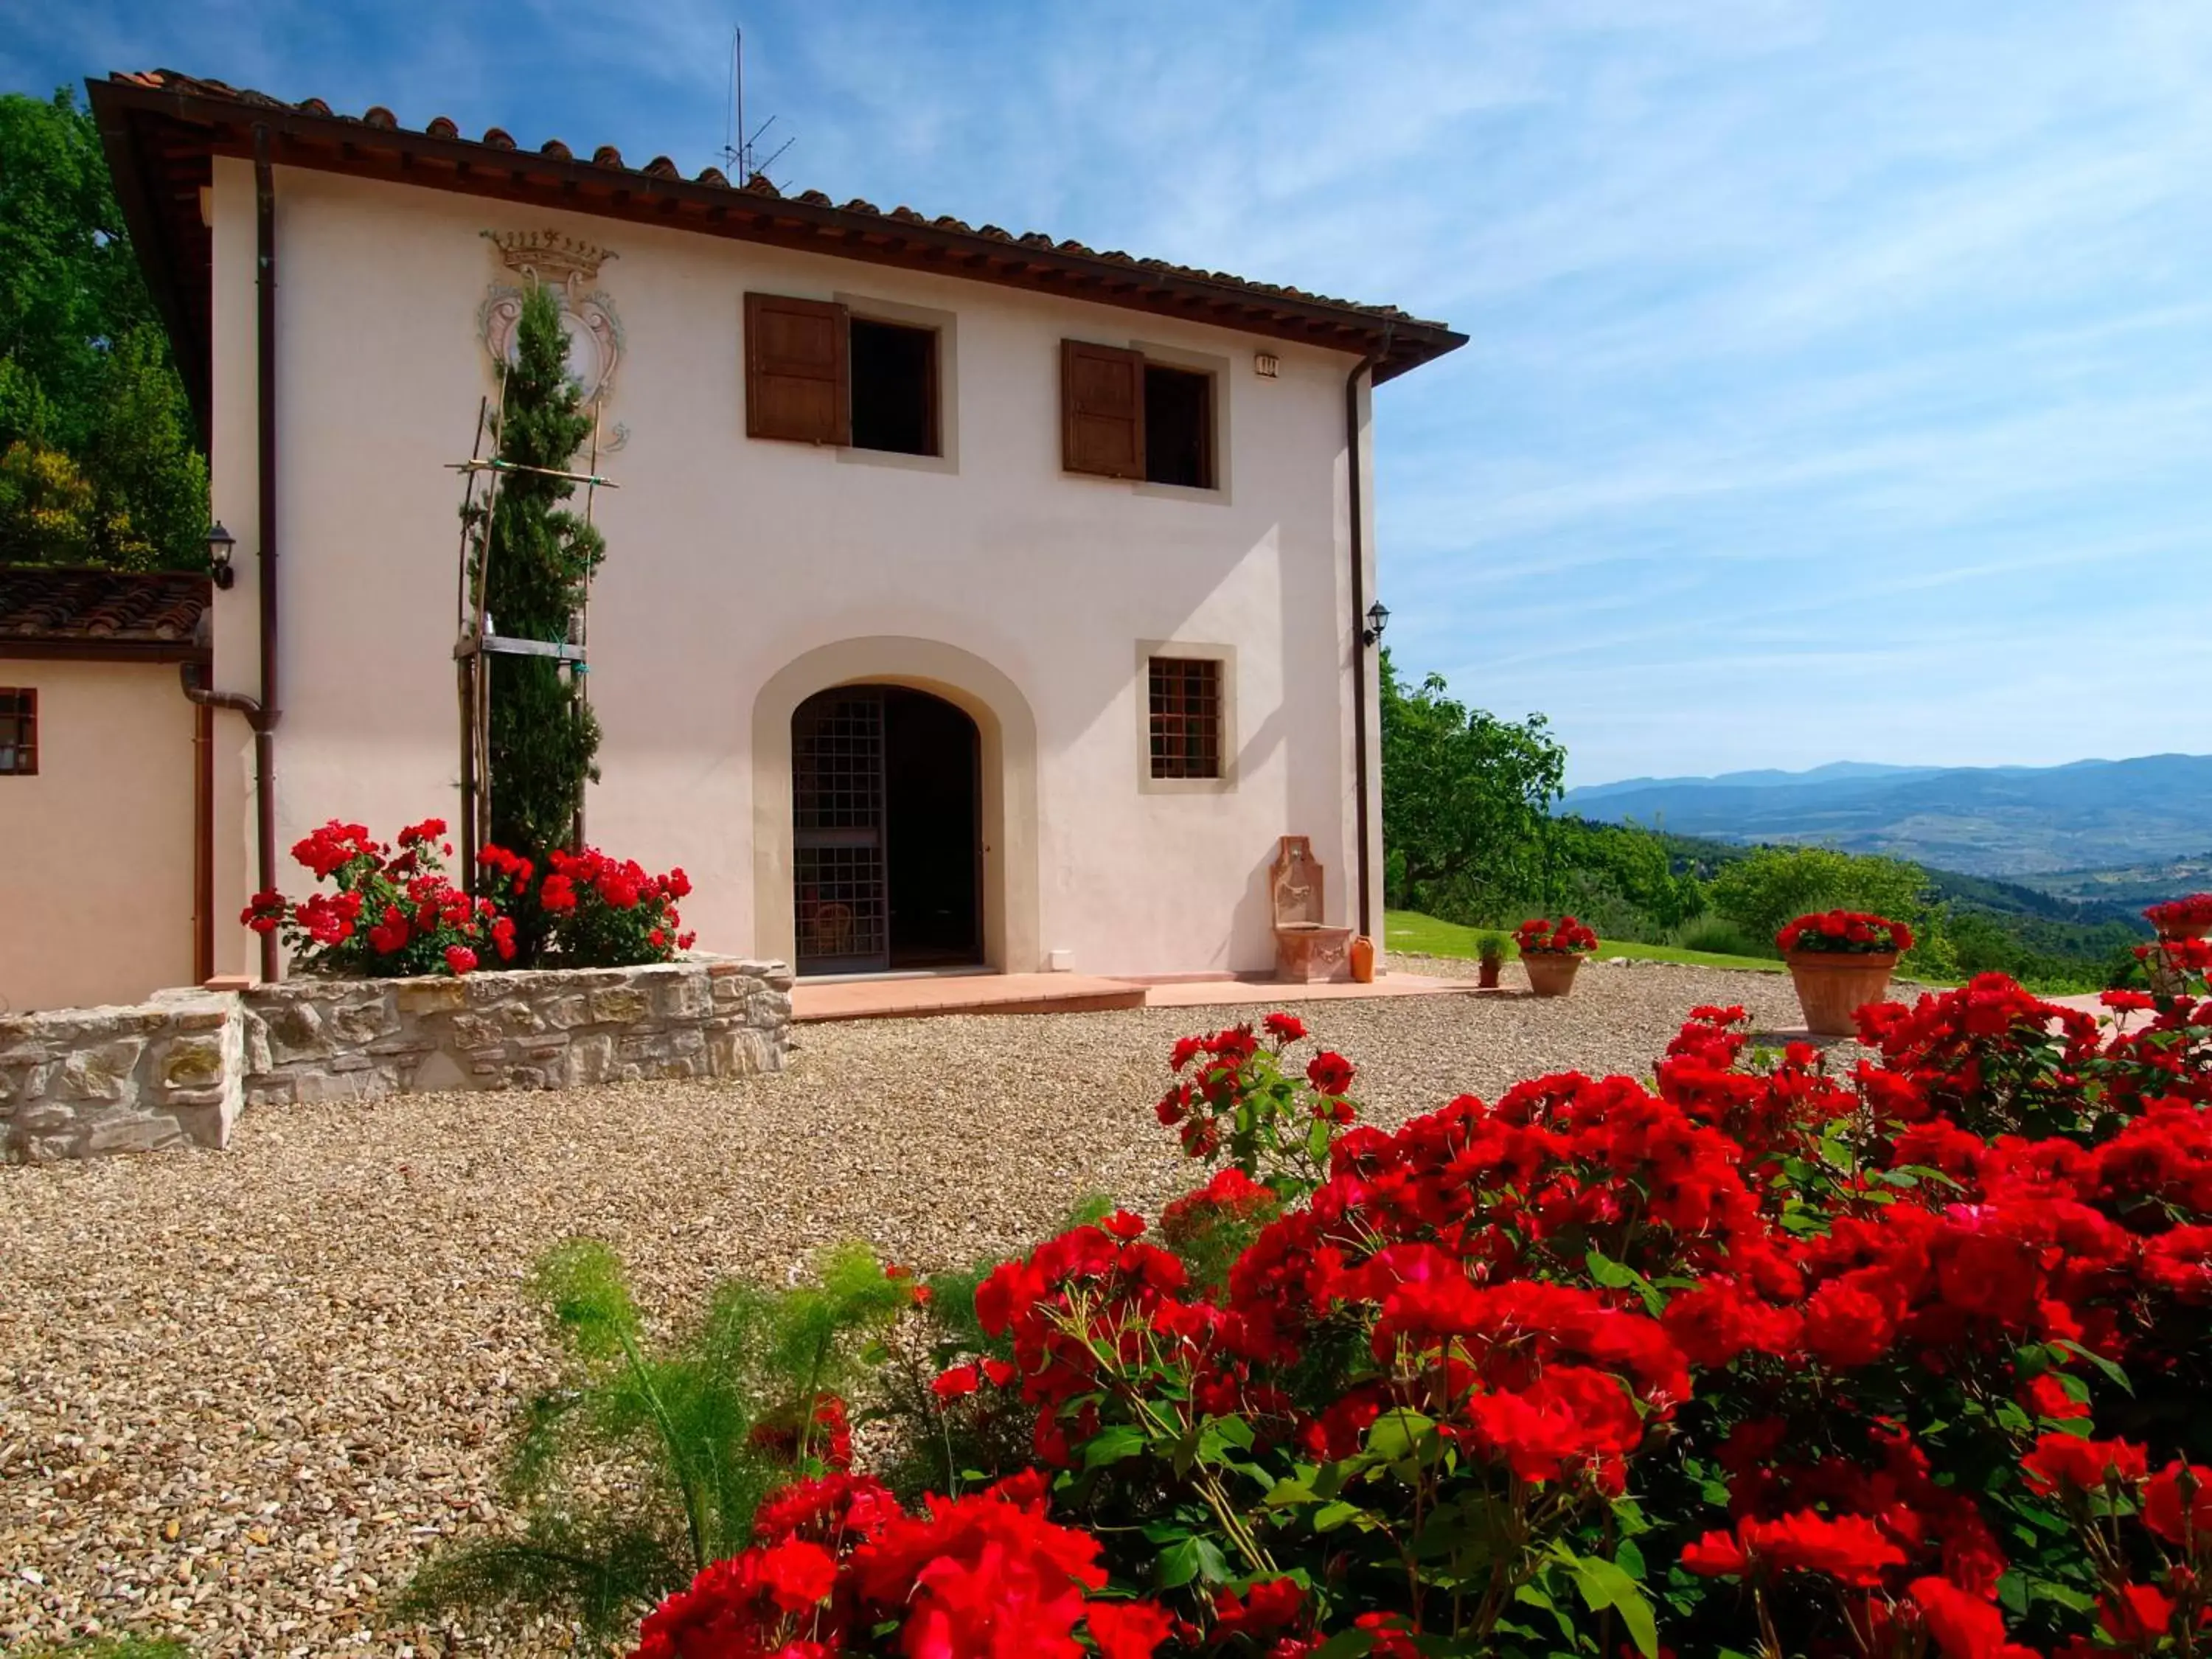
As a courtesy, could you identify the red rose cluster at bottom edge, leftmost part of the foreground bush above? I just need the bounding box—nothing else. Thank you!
[633,1473,1175,1659]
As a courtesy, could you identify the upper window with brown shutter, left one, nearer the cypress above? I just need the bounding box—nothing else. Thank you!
[745,294,942,456]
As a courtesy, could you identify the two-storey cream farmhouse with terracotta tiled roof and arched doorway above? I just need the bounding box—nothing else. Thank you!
[43,71,1462,1000]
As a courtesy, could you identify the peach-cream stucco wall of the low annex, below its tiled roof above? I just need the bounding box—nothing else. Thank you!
[0,657,195,1013]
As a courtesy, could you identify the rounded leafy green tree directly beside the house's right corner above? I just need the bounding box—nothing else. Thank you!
[1380,650,1566,914]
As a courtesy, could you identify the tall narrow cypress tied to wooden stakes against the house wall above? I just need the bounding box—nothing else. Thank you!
[469,288,606,885]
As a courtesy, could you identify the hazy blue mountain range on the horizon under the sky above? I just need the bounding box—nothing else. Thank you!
[1559,754,2212,876]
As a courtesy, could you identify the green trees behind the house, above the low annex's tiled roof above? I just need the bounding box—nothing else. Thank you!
[0,88,208,568]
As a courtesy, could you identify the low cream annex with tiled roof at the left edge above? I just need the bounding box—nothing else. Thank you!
[0,566,215,1013]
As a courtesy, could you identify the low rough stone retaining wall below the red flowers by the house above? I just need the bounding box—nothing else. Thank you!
[0,958,792,1164]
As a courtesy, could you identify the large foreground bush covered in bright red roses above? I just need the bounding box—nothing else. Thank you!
[597,918,2212,1659]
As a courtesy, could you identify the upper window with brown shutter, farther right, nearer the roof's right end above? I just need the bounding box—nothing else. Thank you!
[1060,341,1219,489]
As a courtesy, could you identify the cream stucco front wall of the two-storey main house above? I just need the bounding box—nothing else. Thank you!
[212,161,1380,973]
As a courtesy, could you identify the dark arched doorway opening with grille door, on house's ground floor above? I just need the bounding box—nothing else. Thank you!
[792,686,982,973]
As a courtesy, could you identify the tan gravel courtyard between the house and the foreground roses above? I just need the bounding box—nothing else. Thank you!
[0,958,1823,1655]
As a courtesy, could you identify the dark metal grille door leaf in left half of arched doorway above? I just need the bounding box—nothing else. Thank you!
[792,688,891,973]
